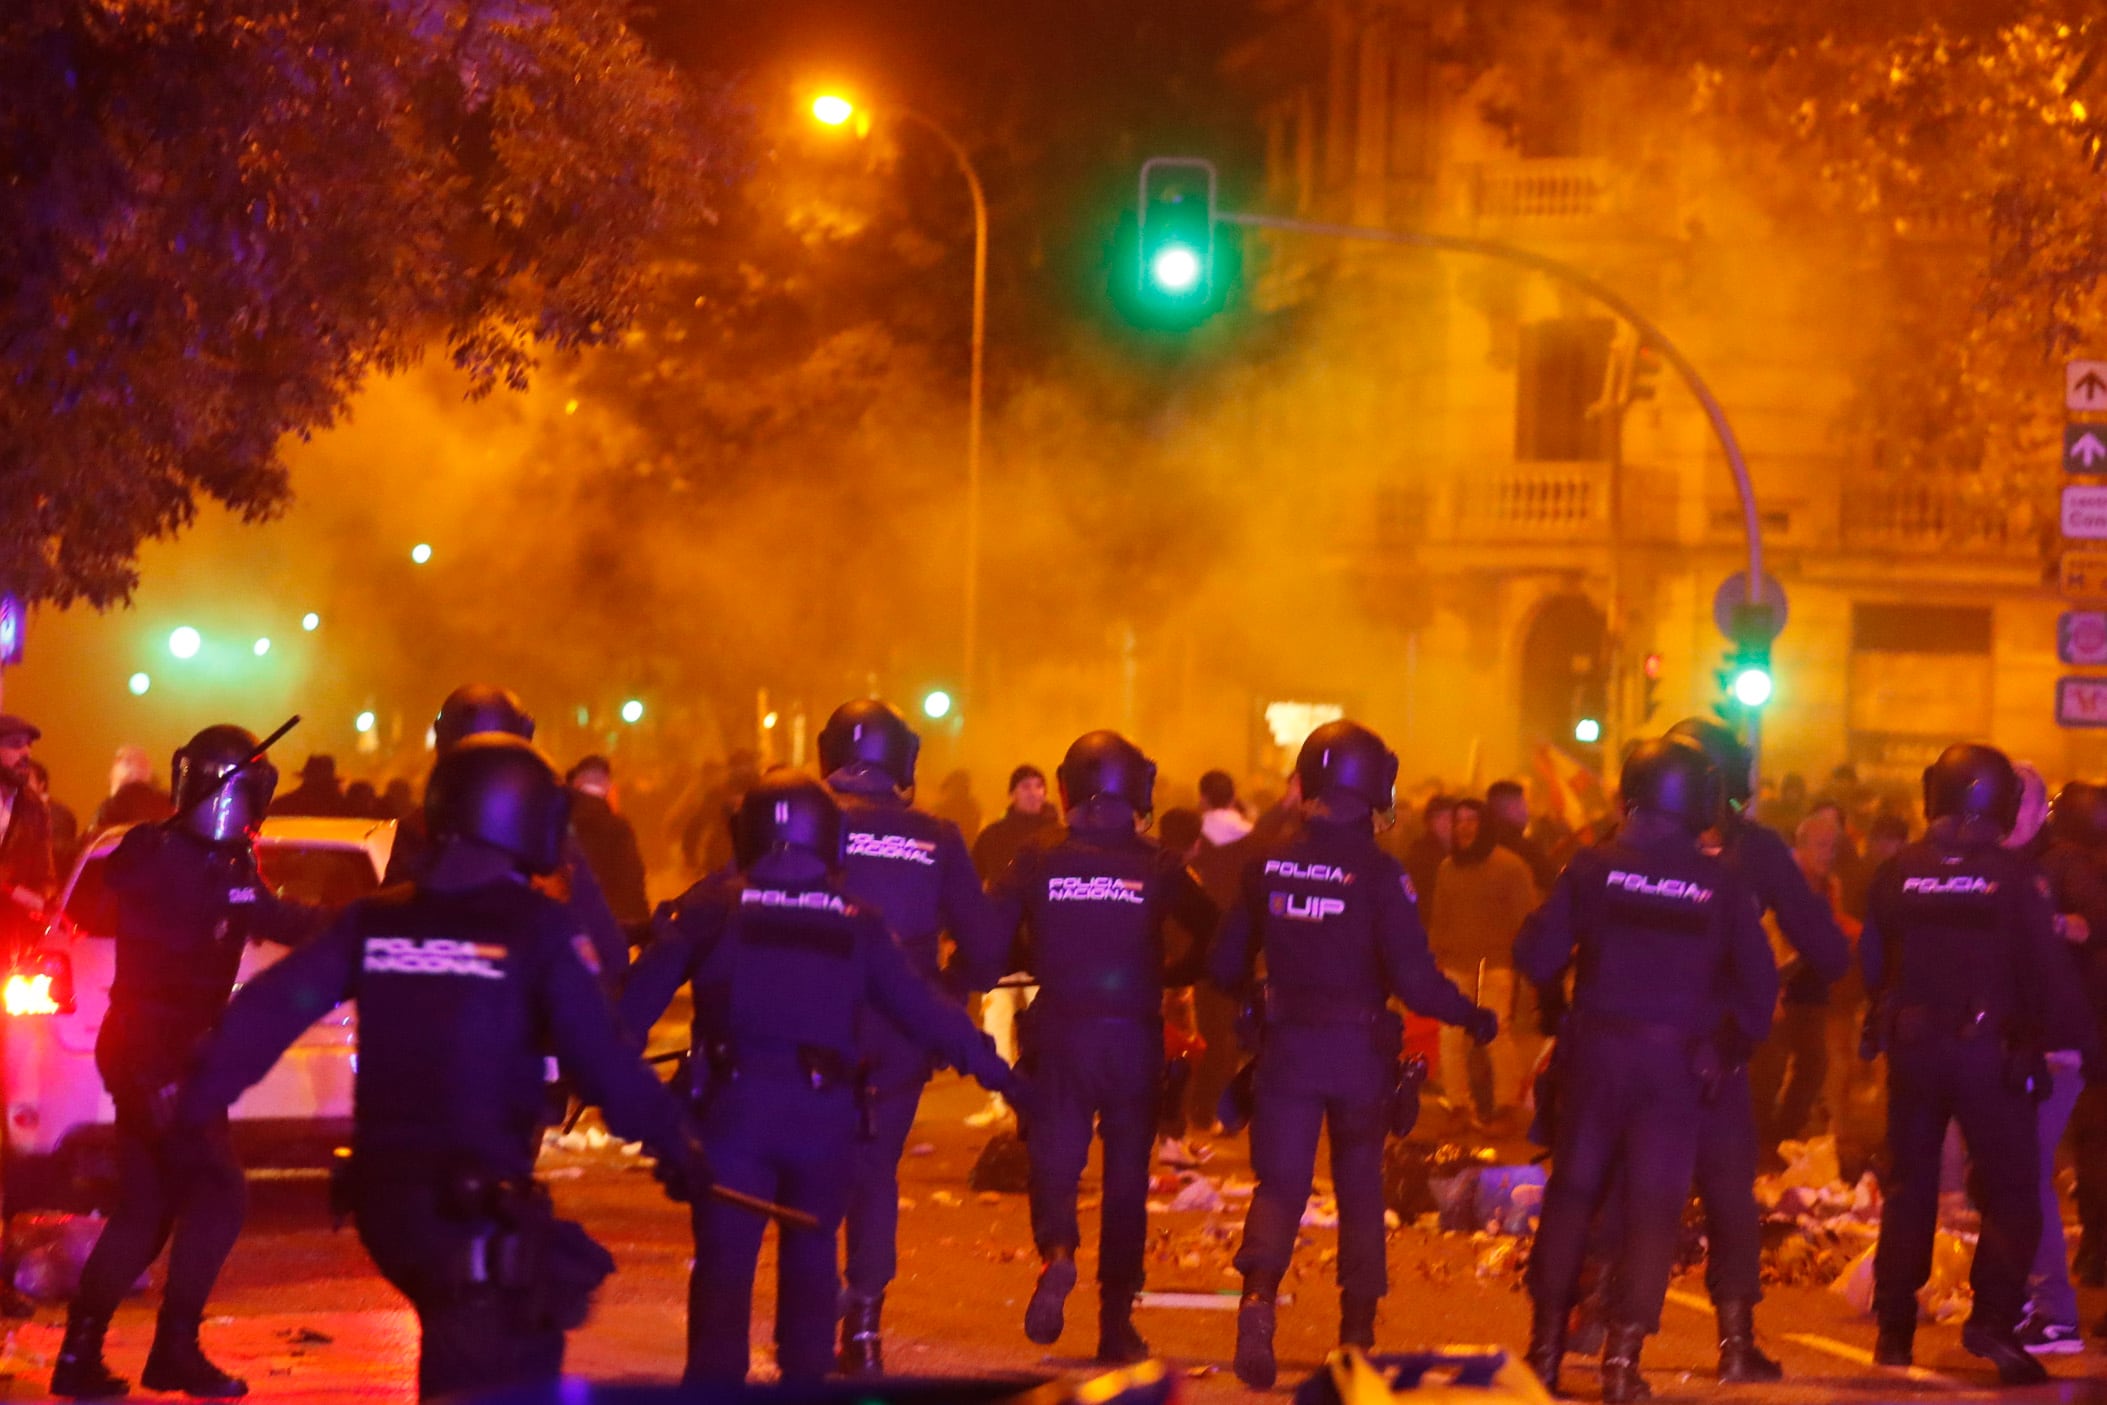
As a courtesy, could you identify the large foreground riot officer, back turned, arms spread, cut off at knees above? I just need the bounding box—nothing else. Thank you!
[177,733,710,1399]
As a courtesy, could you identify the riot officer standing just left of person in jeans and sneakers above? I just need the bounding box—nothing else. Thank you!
[1858,746,2099,1386]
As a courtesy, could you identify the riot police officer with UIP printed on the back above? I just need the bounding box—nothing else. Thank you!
[1212,720,1498,1390]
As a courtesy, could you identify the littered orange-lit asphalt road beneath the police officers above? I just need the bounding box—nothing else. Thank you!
[12,1076,2107,1403]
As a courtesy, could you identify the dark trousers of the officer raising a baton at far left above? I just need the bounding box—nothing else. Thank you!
[74,1100,249,1321]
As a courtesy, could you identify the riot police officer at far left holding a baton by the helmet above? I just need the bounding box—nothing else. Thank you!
[51,725,322,1397]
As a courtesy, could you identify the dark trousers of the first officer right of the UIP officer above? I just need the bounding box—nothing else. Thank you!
[1530,1026,1705,1333]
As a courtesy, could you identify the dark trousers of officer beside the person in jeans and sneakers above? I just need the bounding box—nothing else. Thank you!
[1873,1036,2042,1331]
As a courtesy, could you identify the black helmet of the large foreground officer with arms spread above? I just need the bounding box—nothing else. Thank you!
[424,731,571,874]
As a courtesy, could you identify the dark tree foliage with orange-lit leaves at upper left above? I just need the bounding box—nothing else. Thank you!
[0,0,723,607]
